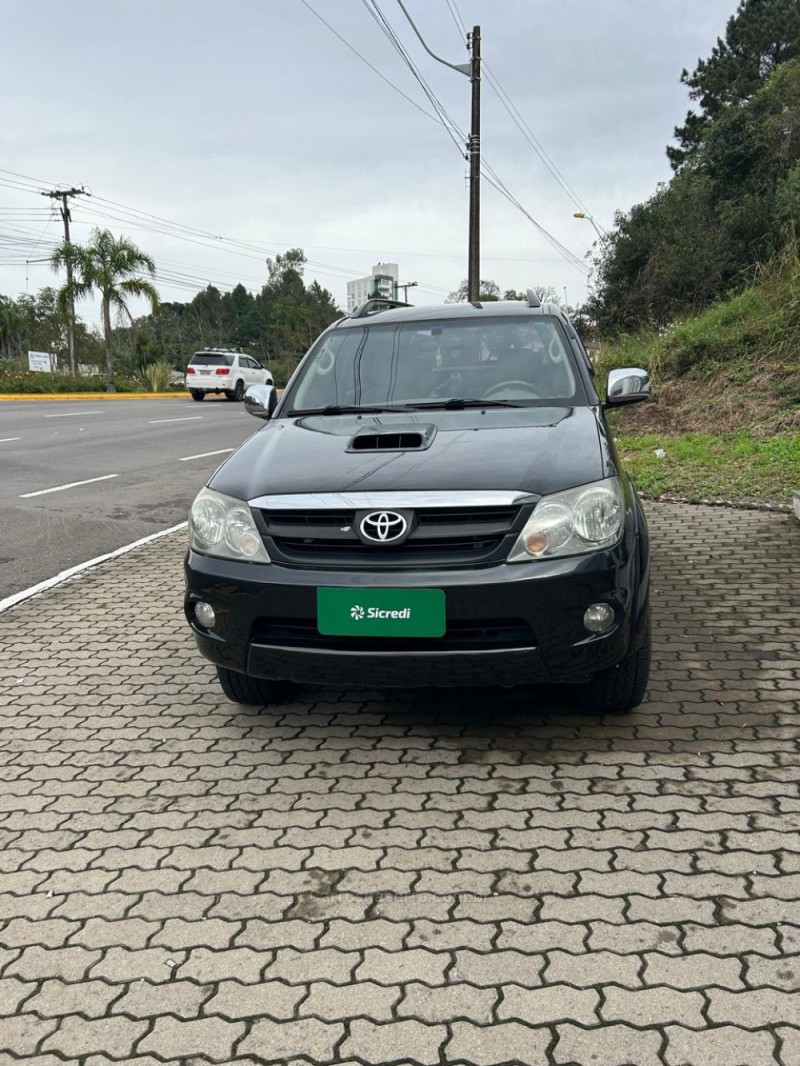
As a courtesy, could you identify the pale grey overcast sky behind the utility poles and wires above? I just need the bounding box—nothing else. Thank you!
[0,0,736,321]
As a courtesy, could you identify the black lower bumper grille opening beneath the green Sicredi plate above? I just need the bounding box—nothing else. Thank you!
[251,618,535,651]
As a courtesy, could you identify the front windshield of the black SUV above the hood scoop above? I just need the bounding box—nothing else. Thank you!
[290,316,582,413]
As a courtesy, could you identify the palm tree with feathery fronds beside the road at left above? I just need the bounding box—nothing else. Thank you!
[50,229,159,392]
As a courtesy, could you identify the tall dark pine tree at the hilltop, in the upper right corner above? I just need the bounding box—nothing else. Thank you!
[667,0,800,171]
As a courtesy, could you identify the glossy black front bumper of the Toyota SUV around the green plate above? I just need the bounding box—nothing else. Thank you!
[185,528,647,689]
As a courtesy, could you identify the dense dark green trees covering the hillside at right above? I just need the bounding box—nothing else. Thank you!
[588,0,800,335]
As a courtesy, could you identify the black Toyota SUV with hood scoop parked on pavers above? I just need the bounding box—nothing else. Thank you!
[185,292,651,711]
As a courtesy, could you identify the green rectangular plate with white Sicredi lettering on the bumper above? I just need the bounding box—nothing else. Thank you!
[317,588,447,636]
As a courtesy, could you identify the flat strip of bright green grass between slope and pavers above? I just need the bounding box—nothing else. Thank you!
[617,431,800,505]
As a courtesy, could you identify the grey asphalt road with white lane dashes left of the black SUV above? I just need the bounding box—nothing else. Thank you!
[0,397,262,600]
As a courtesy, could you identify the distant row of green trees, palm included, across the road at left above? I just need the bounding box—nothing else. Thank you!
[0,238,342,388]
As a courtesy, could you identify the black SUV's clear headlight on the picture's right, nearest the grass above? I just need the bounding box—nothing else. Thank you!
[509,478,625,563]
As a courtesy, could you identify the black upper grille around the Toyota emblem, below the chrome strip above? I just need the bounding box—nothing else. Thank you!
[257,506,527,569]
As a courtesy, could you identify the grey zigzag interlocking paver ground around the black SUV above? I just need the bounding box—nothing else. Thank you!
[0,504,800,1066]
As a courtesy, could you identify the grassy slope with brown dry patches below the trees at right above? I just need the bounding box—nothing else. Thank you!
[597,249,800,506]
